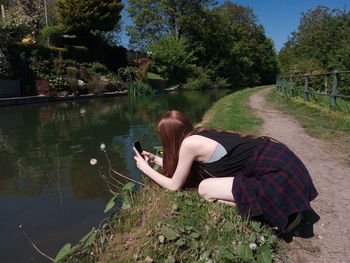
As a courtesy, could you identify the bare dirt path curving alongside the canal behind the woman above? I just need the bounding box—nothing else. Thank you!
[250,88,350,263]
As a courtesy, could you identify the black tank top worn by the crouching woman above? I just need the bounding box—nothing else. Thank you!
[195,130,264,177]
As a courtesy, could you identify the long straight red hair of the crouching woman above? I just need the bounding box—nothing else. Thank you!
[157,110,194,177]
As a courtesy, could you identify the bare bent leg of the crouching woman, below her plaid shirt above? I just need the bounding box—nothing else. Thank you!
[198,177,235,205]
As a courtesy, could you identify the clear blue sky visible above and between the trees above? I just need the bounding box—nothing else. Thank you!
[121,0,350,51]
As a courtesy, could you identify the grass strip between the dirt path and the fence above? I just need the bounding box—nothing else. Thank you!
[267,88,350,159]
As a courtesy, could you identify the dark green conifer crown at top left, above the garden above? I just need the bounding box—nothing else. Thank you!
[57,0,123,36]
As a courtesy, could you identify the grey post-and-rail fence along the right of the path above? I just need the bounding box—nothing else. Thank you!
[276,70,350,108]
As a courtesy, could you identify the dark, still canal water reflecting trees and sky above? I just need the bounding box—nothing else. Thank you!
[0,90,229,262]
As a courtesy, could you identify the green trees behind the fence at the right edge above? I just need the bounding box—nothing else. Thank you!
[278,6,350,74]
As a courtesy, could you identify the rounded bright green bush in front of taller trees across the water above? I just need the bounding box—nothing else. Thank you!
[149,35,196,83]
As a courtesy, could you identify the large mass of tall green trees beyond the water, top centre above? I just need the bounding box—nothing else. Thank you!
[128,0,277,87]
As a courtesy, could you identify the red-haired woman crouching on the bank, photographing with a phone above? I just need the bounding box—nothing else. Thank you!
[134,110,317,233]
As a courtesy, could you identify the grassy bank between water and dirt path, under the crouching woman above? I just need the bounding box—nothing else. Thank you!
[55,87,281,262]
